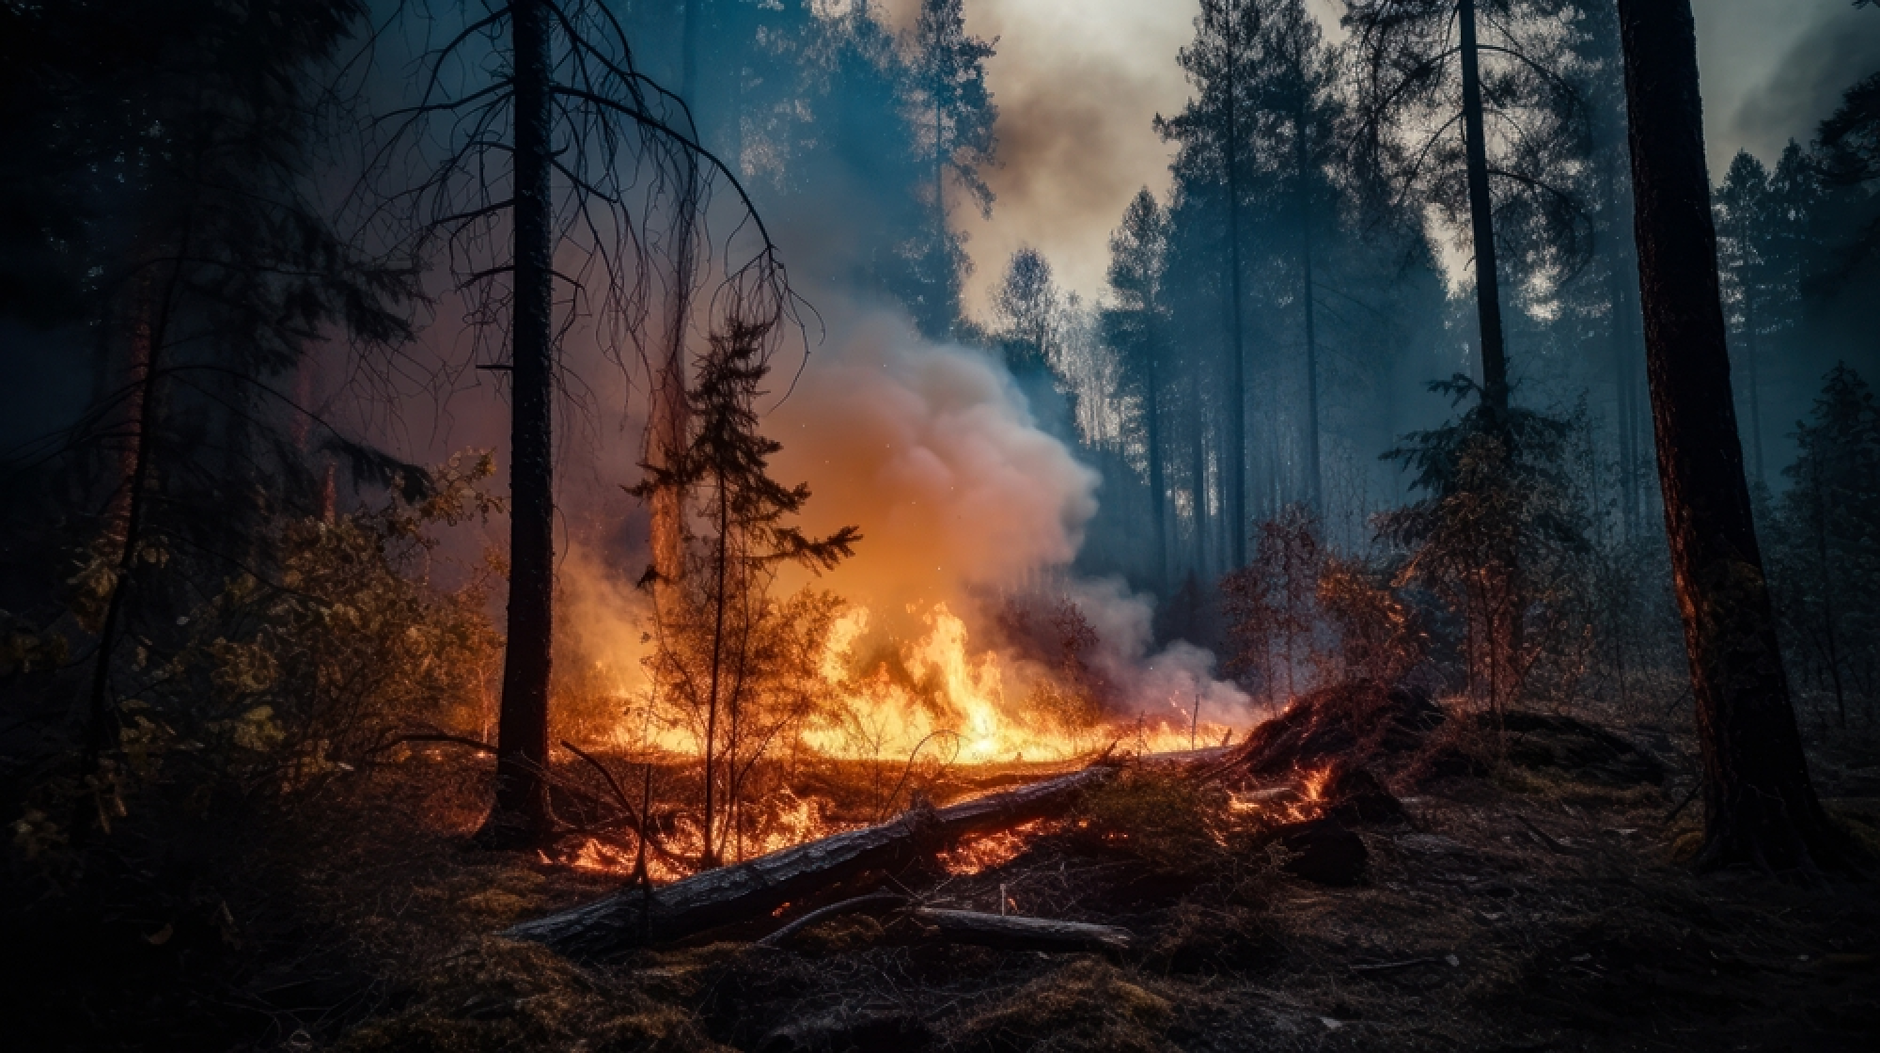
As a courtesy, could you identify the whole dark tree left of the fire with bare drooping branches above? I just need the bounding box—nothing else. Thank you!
[372,0,791,846]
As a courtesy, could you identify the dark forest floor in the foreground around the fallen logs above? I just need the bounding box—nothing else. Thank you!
[18,703,1880,1053]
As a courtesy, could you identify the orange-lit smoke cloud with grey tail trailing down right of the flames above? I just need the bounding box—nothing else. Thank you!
[767,310,1250,724]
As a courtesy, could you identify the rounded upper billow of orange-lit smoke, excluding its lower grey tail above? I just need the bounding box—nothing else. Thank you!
[765,312,1098,609]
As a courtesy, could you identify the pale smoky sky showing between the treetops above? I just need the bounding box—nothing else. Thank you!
[885,0,1880,314]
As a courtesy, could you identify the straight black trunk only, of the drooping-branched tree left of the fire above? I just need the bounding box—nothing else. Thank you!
[478,0,555,848]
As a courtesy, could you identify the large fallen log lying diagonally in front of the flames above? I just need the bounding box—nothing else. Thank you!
[502,765,1117,959]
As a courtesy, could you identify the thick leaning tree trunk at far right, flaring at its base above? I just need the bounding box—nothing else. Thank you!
[1619,0,1854,871]
